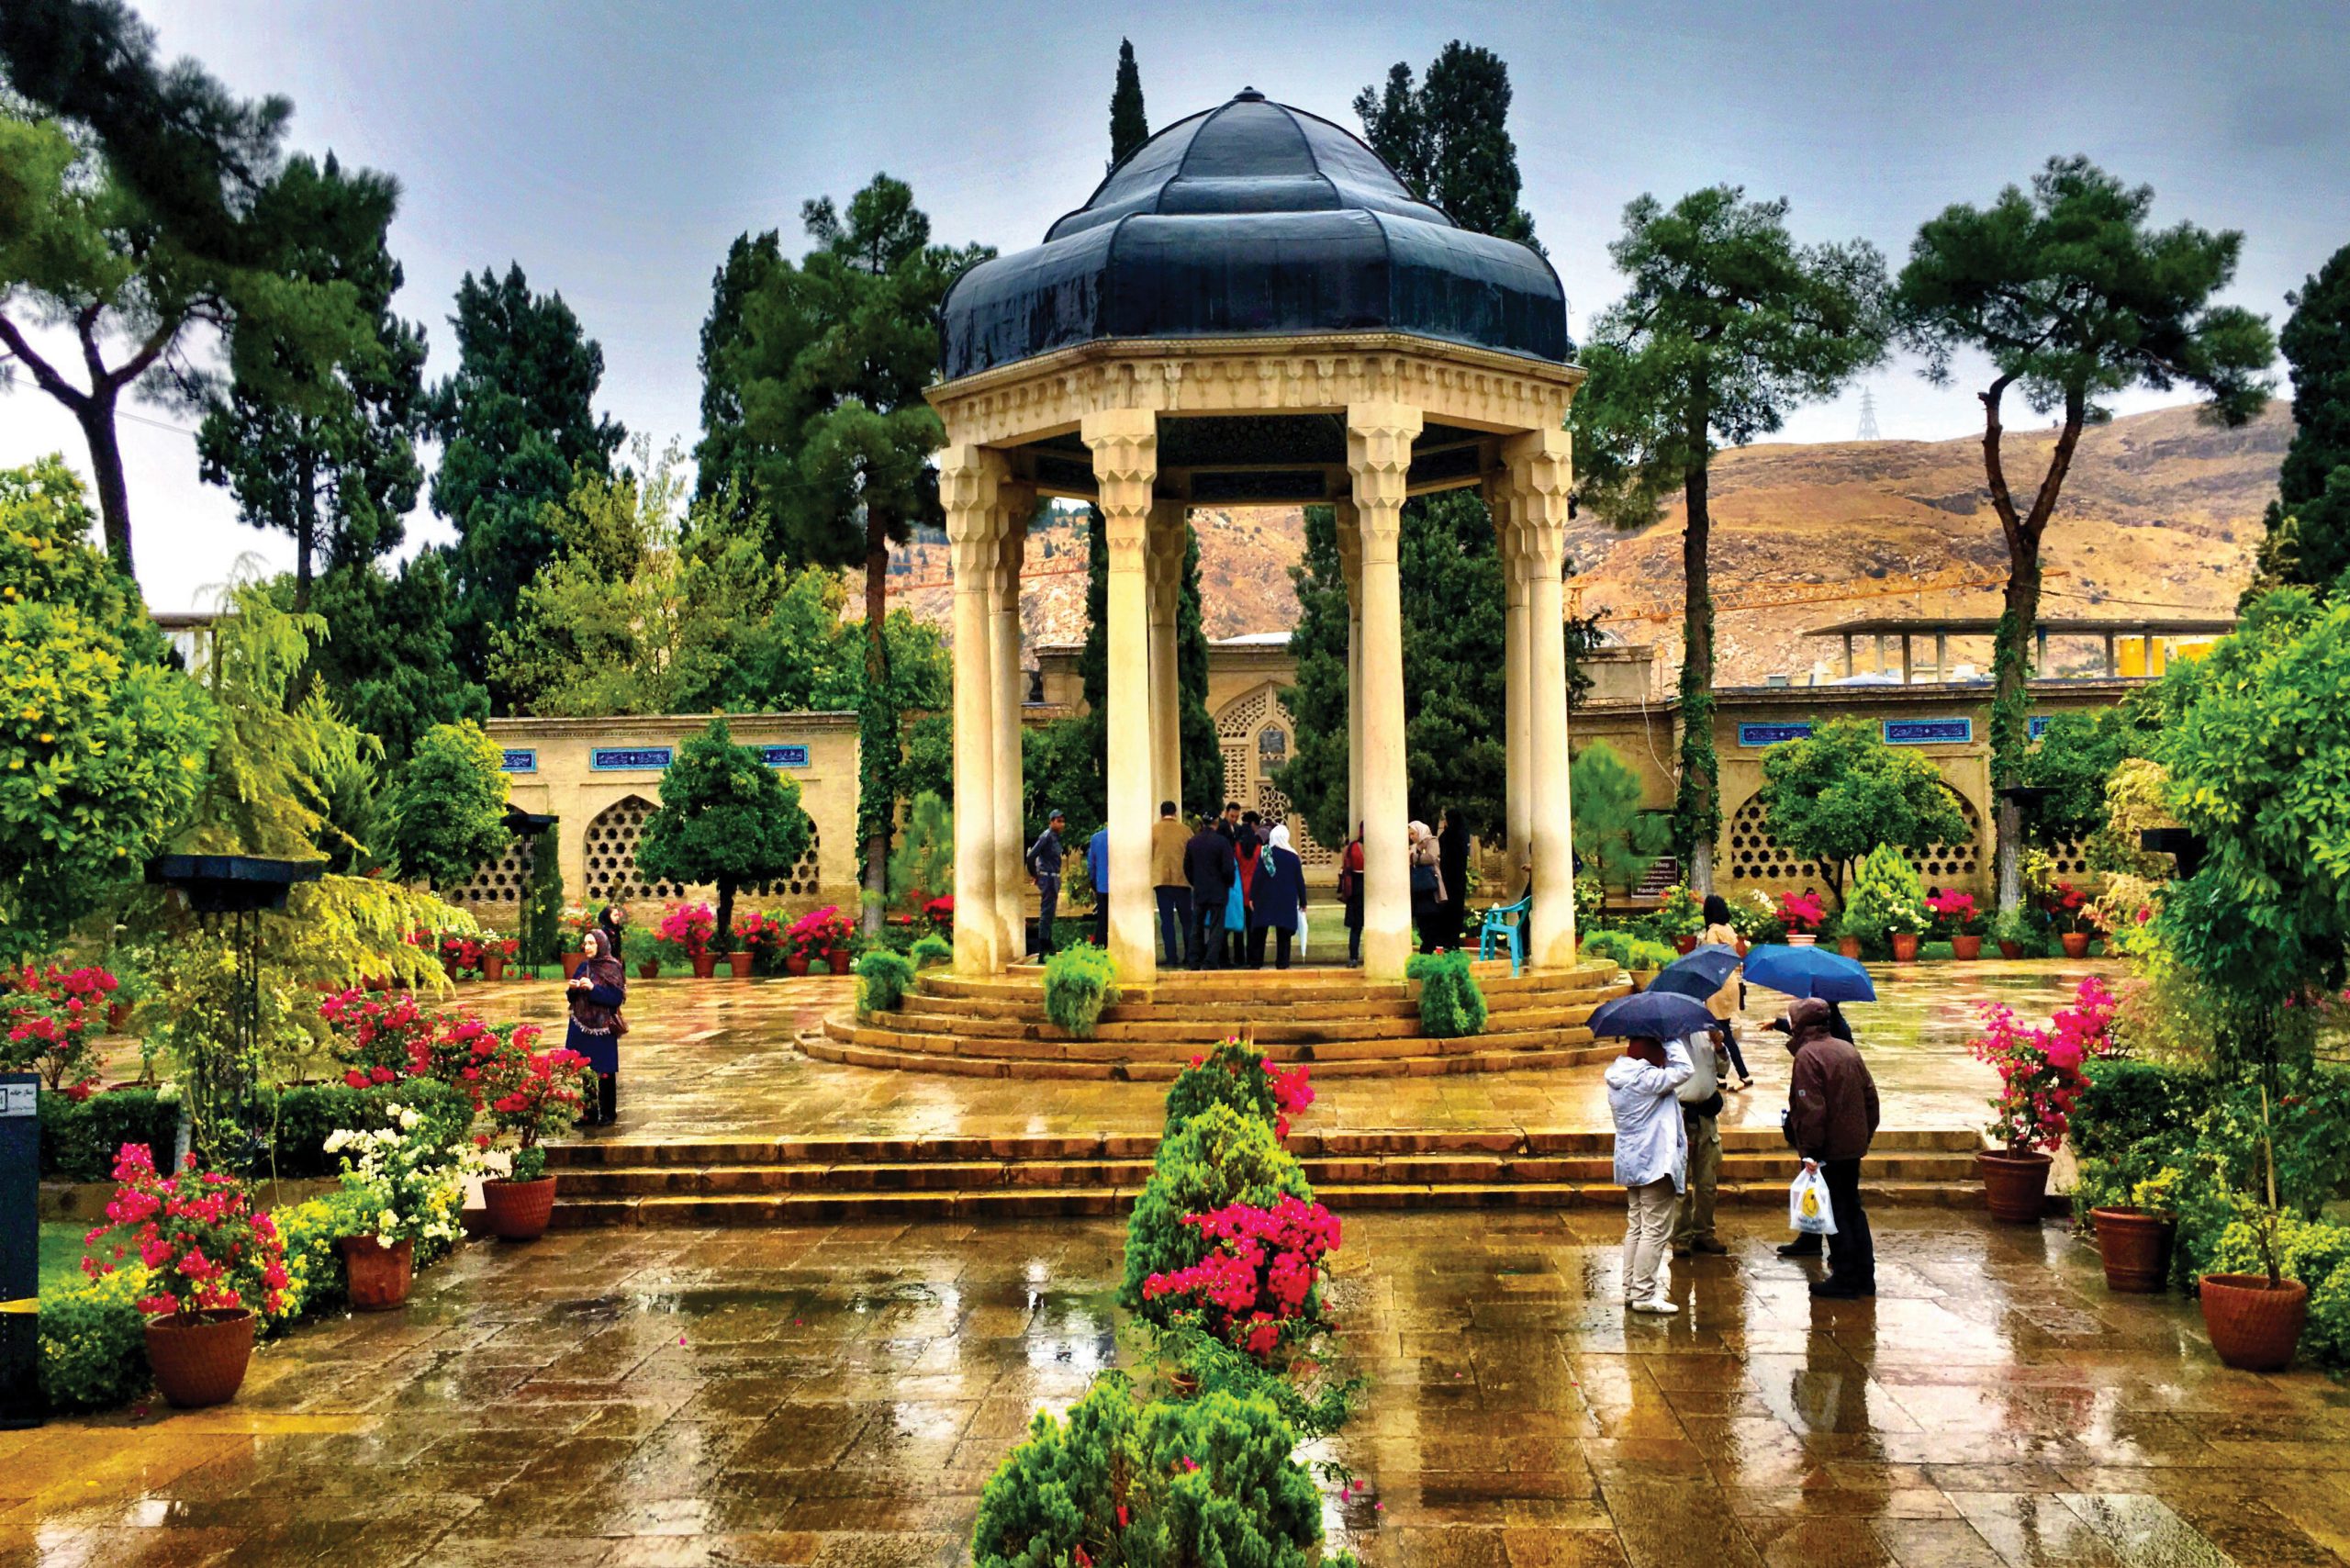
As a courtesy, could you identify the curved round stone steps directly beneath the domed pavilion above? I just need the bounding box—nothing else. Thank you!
[799,961,1631,1081]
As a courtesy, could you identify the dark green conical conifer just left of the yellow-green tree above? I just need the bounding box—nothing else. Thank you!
[430,263,622,690]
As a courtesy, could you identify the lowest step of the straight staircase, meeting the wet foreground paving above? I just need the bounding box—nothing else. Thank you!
[554,1180,1984,1229]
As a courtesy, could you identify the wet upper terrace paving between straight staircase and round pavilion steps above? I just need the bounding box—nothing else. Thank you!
[427,959,2120,1140]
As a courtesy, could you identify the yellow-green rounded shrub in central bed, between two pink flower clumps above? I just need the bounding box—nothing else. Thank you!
[1119,1105,1314,1328]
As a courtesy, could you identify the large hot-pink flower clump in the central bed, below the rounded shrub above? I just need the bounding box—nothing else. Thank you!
[1142,1194,1339,1366]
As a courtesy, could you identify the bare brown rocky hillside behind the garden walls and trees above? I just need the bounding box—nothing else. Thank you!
[895,404,2291,684]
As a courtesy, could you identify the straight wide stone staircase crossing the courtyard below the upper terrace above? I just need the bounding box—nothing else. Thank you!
[547,1128,1984,1229]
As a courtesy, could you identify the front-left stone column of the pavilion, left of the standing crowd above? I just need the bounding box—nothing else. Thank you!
[1081,409,1158,985]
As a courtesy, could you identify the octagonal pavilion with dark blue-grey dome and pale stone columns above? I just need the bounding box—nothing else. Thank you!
[931,89,1582,985]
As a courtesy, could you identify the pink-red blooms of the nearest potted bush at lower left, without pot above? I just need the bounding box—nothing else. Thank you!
[83,1143,286,1316]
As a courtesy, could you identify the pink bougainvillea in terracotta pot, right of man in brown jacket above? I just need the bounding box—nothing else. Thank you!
[1967,976,2115,1225]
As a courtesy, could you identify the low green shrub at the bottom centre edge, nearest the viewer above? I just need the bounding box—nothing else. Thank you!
[970,1372,1351,1568]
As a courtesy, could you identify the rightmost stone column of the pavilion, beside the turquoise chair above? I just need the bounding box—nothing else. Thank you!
[1502,431,1574,969]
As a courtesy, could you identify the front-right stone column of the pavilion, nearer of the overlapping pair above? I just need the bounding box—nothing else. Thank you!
[1347,402,1419,980]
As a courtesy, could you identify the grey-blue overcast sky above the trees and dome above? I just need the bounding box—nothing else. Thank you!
[0,0,2350,609]
